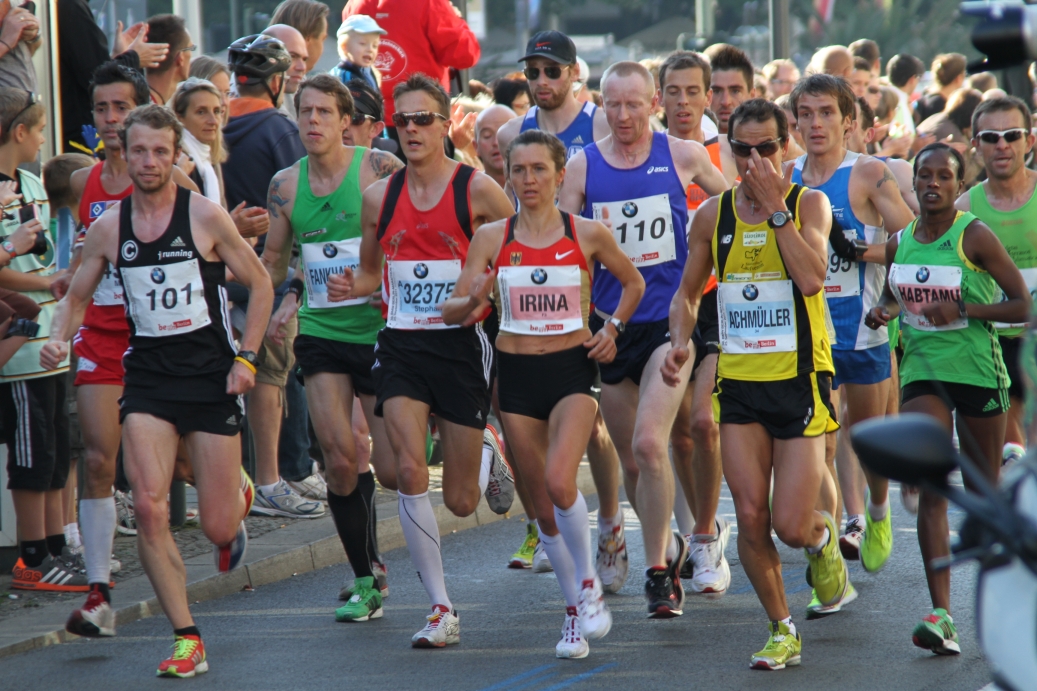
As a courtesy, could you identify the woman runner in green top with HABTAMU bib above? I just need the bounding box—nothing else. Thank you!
[865,143,1031,655]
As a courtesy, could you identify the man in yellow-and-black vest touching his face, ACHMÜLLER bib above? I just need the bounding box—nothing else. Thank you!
[662,99,848,669]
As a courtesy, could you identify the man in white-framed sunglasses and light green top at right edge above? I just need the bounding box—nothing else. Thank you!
[955,96,1037,462]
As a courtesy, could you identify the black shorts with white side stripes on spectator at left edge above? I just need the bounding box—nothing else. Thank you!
[0,371,72,492]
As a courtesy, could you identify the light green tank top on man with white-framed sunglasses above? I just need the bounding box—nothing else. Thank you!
[969,185,1037,338]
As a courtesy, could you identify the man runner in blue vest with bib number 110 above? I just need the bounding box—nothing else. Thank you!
[558,62,728,618]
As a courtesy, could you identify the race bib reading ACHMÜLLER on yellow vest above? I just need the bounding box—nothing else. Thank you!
[717,280,796,354]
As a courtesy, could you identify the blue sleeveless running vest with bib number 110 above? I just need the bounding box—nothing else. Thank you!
[583,132,688,324]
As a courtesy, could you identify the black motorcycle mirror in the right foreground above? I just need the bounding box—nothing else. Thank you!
[849,413,958,485]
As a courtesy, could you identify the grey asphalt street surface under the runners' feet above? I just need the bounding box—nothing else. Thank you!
[3,481,989,691]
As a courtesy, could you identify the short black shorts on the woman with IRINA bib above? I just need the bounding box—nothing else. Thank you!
[497,346,601,420]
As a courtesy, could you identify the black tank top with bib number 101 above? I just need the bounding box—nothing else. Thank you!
[116,187,236,403]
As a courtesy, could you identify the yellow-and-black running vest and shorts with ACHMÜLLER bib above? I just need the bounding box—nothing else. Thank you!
[712,185,839,439]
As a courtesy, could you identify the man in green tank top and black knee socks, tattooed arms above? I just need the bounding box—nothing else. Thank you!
[256,75,402,621]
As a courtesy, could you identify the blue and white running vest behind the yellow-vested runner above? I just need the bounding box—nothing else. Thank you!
[792,151,889,351]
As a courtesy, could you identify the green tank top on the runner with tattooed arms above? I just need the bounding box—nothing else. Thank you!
[291,146,385,344]
